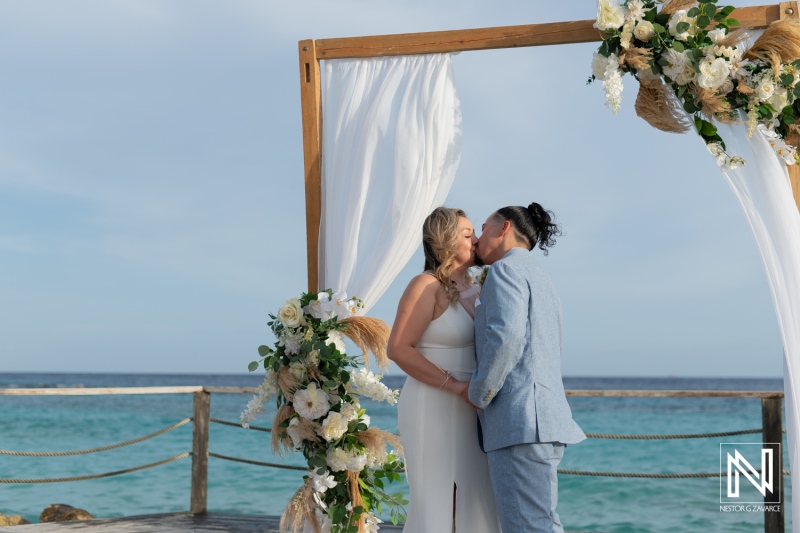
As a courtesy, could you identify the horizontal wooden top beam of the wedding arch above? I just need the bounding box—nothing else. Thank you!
[316,4,781,59]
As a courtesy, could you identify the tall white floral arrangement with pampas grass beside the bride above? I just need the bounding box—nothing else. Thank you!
[241,290,408,533]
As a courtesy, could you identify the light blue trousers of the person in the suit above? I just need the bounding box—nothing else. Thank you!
[487,442,565,533]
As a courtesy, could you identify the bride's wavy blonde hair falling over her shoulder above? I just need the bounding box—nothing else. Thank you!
[422,207,467,305]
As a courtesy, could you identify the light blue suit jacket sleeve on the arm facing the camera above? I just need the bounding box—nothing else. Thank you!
[469,262,528,409]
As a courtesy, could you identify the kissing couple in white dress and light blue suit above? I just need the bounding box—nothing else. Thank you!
[388,203,586,533]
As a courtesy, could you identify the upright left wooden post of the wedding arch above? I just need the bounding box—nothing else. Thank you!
[299,39,322,292]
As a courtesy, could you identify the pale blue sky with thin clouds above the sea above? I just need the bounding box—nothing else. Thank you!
[0,0,782,376]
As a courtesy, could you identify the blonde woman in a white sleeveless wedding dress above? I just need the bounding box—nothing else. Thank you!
[388,207,500,533]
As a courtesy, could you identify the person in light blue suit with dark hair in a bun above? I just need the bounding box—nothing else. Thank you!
[464,203,586,533]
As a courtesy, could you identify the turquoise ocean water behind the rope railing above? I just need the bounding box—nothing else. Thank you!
[0,373,791,533]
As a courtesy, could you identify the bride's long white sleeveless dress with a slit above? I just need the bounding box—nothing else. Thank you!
[397,291,500,533]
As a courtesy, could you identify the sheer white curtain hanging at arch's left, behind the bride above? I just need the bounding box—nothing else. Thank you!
[319,54,461,312]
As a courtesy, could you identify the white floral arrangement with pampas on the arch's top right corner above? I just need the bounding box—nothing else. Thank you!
[589,0,800,168]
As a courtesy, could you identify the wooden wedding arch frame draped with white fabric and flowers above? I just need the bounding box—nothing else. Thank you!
[298,1,800,292]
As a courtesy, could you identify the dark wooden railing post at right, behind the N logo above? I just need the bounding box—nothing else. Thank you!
[761,397,786,533]
